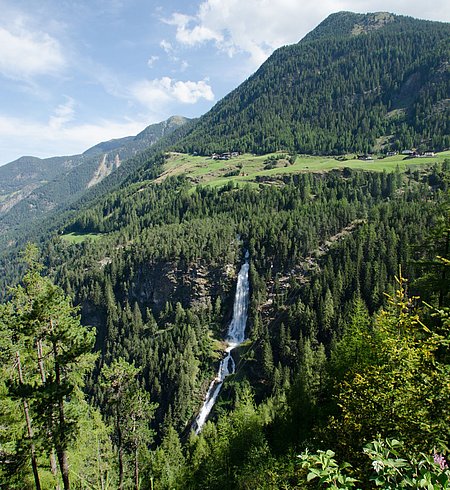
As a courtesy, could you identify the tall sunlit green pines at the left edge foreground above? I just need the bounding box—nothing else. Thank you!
[0,246,95,488]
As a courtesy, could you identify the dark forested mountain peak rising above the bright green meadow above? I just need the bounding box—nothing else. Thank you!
[176,12,450,154]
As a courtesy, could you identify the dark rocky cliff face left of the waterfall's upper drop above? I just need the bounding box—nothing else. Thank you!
[76,249,241,340]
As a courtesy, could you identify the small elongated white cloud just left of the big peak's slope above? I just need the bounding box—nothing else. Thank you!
[131,77,214,110]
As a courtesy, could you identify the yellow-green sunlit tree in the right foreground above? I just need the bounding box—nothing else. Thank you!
[330,275,450,464]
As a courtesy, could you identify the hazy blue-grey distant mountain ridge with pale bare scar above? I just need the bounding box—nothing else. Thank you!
[0,116,188,234]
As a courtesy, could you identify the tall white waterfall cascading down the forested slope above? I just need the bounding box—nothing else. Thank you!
[193,252,249,434]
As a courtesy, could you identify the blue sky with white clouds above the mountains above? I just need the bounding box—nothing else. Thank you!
[0,0,450,165]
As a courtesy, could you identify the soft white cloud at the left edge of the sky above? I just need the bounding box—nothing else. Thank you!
[0,24,66,80]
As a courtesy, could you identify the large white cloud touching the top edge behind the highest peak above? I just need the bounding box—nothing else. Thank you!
[164,0,449,69]
